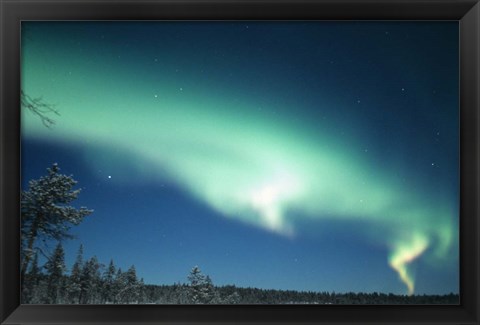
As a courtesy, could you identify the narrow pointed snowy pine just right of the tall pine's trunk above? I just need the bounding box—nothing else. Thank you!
[45,242,66,304]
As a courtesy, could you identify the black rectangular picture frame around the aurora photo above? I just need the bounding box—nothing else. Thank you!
[0,0,480,325]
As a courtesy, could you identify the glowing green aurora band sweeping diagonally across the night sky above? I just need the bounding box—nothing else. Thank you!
[22,38,458,294]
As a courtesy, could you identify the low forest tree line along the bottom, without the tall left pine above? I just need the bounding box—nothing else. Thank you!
[23,244,459,305]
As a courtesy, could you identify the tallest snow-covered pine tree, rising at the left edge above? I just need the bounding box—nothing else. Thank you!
[21,163,93,283]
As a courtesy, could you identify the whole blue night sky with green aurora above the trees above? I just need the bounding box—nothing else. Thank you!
[22,21,459,294]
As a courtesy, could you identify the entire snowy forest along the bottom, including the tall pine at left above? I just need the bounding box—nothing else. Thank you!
[20,164,459,304]
